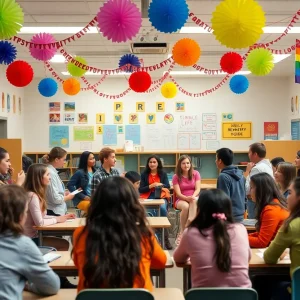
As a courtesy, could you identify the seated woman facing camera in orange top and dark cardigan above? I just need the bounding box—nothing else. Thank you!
[139,155,173,250]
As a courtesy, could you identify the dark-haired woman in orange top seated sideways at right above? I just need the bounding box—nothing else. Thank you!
[248,173,289,248]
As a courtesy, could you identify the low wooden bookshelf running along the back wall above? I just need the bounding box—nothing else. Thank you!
[25,150,249,184]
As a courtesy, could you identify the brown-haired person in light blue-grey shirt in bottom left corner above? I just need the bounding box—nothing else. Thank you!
[0,185,60,300]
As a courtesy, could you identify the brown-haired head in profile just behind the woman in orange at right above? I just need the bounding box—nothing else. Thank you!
[274,162,296,199]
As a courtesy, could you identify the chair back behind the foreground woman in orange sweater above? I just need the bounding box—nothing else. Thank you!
[76,289,154,300]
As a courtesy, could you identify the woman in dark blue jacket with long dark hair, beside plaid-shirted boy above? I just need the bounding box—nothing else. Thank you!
[67,151,96,207]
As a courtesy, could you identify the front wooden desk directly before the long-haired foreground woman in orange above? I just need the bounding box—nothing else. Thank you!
[49,251,174,287]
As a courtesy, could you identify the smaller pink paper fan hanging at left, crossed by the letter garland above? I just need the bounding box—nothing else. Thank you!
[30,33,57,61]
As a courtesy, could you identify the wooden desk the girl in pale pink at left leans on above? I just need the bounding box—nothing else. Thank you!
[34,217,171,246]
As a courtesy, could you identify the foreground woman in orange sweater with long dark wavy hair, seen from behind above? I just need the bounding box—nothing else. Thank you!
[72,177,167,292]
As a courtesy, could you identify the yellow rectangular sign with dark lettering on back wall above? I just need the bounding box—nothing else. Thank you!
[222,122,252,140]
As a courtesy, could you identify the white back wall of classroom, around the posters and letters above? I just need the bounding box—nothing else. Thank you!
[24,77,290,152]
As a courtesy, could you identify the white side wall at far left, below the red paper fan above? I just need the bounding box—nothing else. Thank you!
[0,72,24,139]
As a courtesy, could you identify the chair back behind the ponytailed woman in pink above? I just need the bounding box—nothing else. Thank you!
[185,288,258,300]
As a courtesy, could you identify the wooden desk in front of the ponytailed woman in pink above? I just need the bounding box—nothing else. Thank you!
[176,249,291,293]
